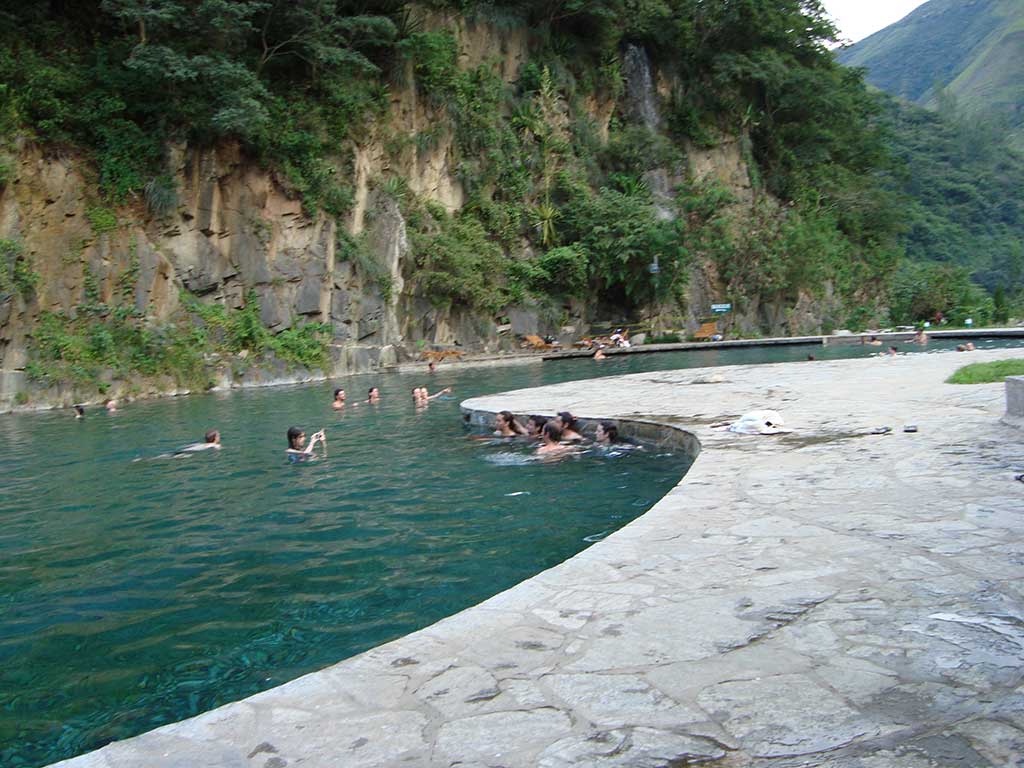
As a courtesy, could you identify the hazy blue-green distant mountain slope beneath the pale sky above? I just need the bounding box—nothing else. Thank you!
[838,0,1024,147]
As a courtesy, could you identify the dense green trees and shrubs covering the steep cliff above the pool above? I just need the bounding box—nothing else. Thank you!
[0,0,913,387]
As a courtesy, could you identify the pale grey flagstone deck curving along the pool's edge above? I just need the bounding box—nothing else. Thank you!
[54,350,1024,768]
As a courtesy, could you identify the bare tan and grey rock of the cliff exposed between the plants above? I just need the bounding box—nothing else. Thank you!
[0,17,831,410]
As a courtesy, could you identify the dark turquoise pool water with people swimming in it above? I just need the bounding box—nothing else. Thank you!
[0,341,1020,766]
